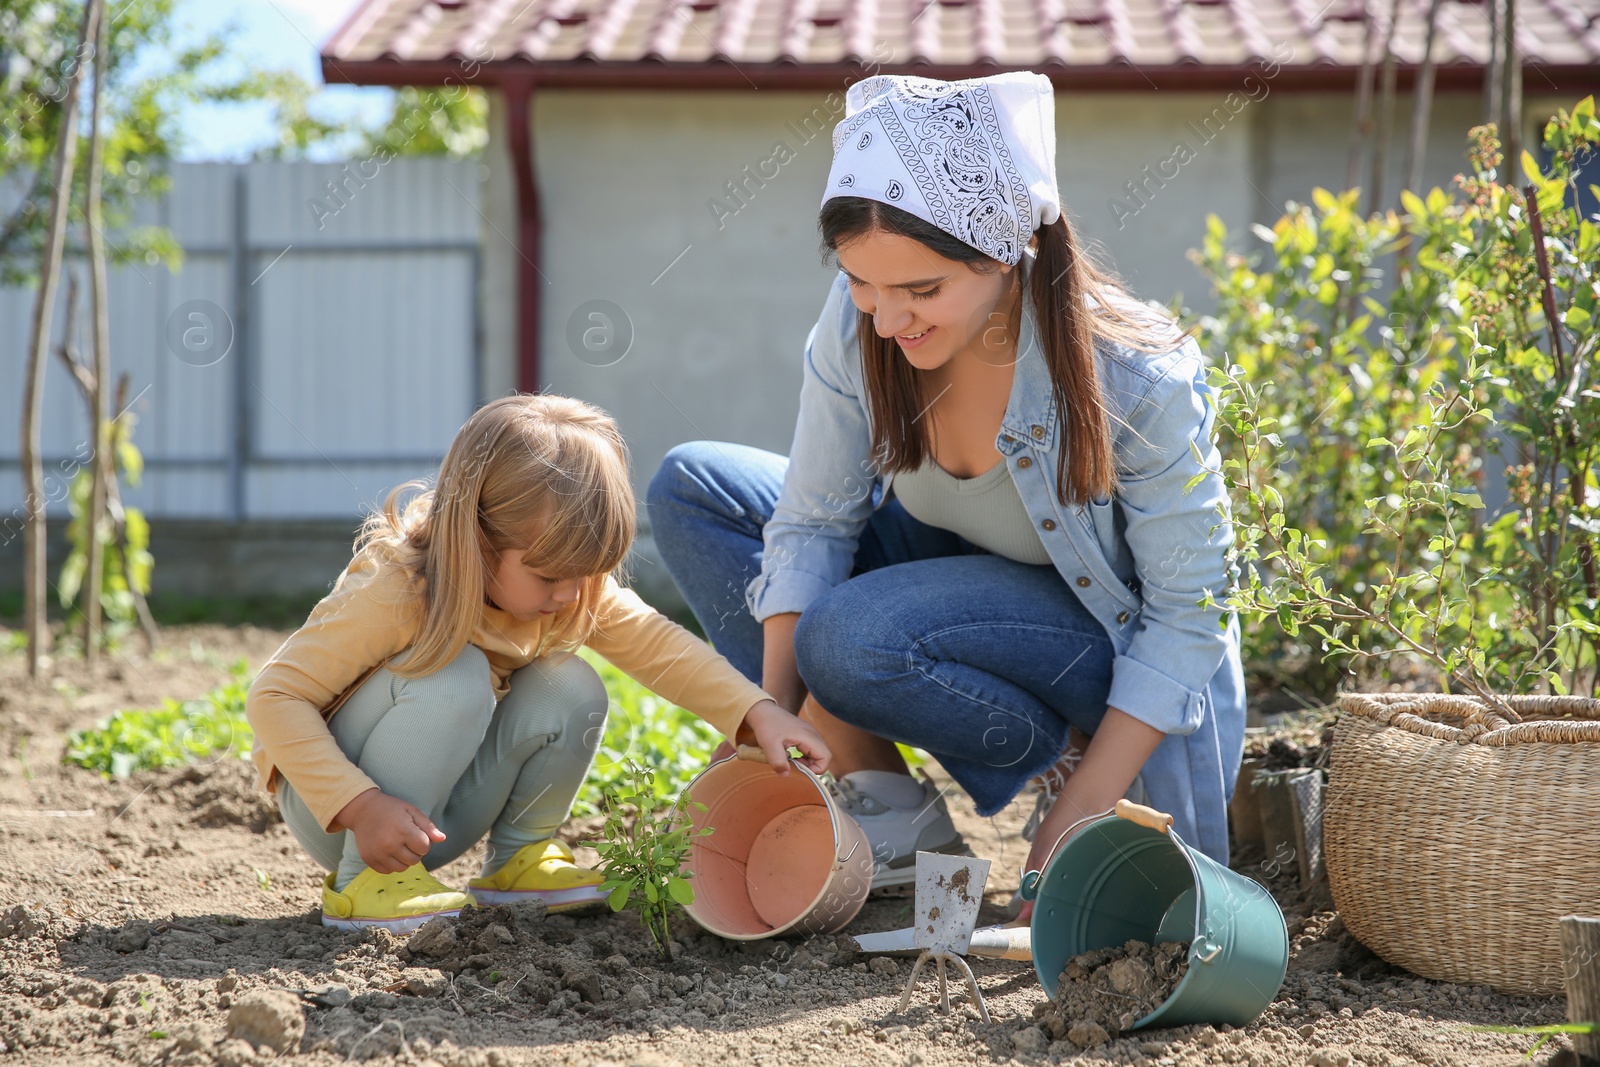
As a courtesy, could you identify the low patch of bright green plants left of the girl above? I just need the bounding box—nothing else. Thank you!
[62,659,254,777]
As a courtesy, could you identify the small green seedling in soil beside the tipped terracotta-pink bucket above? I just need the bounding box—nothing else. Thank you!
[595,758,710,960]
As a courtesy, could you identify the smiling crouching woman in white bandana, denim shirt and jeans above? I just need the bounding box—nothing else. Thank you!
[648,72,1245,908]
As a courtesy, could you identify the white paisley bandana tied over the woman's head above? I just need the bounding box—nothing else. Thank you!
[822,70,1061,266]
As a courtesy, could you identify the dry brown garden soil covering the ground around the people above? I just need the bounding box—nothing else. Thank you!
[0,625,1565,1067]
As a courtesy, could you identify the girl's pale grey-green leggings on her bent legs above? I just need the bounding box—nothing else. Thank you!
[278,645,608,889]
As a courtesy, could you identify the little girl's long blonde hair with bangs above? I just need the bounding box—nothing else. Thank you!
[355,395,637,677]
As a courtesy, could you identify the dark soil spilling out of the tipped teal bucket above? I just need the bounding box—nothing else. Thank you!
[1034,941,1189,1048]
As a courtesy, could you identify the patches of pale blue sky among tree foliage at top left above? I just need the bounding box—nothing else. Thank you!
[173,0,392,162]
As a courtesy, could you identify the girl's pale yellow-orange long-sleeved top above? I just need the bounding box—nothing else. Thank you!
[245,549,768,829]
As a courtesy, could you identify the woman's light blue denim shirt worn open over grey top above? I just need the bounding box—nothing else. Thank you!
[746,258,1245,861]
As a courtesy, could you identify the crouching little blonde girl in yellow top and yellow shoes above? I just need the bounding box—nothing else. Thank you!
[246,395,829,933]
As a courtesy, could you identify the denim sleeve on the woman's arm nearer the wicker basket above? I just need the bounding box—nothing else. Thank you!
[1107,339,1232,734]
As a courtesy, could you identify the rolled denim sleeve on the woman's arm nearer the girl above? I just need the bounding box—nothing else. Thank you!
[746,274,878,621]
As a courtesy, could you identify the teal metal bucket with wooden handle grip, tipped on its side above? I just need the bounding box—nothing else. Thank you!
[1022,800,1290,1030]
